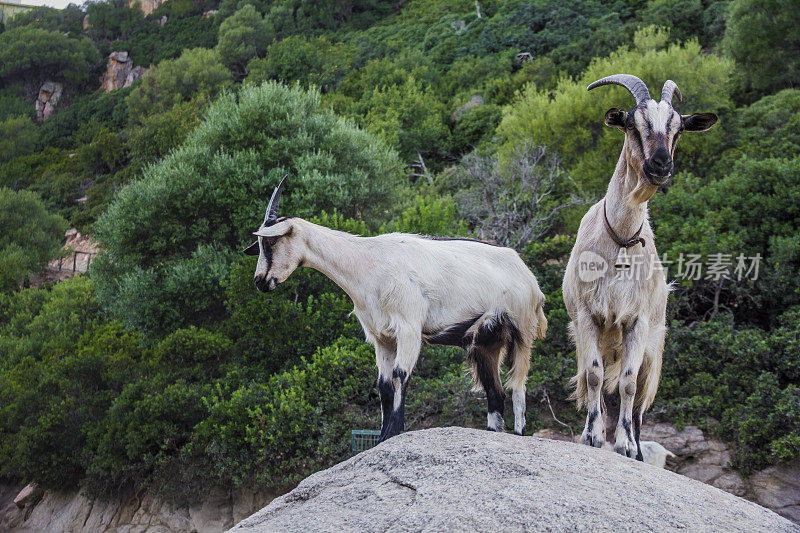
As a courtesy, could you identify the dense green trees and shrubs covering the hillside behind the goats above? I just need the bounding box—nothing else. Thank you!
[0,0,800,496]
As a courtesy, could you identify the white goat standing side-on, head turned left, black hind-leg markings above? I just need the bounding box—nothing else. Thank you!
[245,181,547,441]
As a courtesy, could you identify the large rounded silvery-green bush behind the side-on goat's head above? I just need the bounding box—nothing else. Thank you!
[94,83,403,332]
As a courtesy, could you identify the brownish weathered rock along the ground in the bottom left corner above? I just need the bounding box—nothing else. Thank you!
[0,485,274,533]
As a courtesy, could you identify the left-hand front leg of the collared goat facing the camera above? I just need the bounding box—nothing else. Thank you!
[575,313,606,448]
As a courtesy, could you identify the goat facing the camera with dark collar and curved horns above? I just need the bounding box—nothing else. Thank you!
[563,74,717,461]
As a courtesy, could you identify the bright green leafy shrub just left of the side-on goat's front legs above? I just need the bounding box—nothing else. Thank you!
[186,340,379,488]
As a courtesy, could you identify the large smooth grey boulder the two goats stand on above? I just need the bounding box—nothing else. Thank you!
[232,428,800,533]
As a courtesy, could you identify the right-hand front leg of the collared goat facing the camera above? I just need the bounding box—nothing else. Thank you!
[614,319,648,458]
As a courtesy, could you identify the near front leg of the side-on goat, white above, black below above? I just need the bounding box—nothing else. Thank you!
[379,328,422,442]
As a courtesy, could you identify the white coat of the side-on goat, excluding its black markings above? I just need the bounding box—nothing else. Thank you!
[256,218,547,434]
